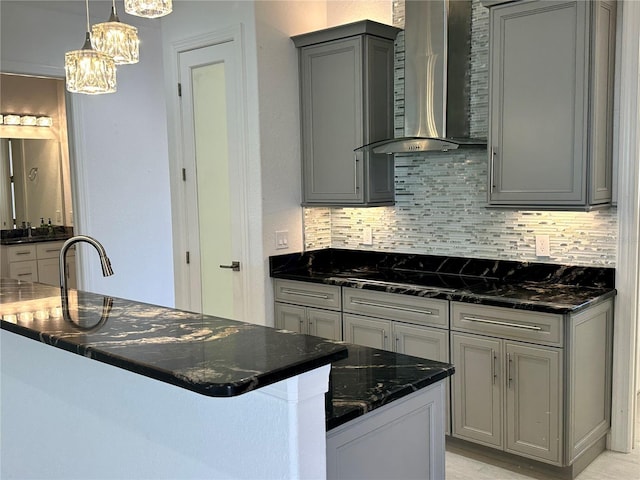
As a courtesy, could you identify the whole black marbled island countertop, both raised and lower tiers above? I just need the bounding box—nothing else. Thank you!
[0,279,454,429]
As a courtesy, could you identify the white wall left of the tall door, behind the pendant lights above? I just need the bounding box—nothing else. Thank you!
[0,1,174,306]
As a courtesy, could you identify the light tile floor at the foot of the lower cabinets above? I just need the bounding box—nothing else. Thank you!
[446,402,640,480]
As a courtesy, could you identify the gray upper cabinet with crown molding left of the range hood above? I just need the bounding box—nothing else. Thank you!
[293,20,399,206]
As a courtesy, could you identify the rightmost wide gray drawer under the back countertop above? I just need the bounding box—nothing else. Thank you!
[451,302,563,346]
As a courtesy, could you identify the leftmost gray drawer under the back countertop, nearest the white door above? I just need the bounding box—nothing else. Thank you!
[274,279,342,310]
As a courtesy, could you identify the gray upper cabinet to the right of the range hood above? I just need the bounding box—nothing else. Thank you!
[486,0,616,210]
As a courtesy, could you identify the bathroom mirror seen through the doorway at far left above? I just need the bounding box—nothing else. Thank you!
[0,138,65,229]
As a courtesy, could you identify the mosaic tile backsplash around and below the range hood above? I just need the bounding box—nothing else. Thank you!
[304,0,618,267]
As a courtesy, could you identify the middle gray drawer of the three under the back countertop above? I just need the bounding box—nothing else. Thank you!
[342,287,449,328]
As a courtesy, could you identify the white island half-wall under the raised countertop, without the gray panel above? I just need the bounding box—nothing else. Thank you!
[0,330,330,480]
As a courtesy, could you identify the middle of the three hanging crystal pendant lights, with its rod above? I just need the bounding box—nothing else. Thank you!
[91,0,140,65]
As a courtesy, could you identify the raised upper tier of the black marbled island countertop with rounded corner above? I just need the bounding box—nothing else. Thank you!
[0,279,347,397]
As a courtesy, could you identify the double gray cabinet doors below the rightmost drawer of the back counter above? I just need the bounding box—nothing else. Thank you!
[452,333,562,465]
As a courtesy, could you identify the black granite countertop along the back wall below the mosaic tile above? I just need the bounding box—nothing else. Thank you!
[269,249,616,314]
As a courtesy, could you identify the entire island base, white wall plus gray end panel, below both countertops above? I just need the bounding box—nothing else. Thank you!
[0,330,445,480]
